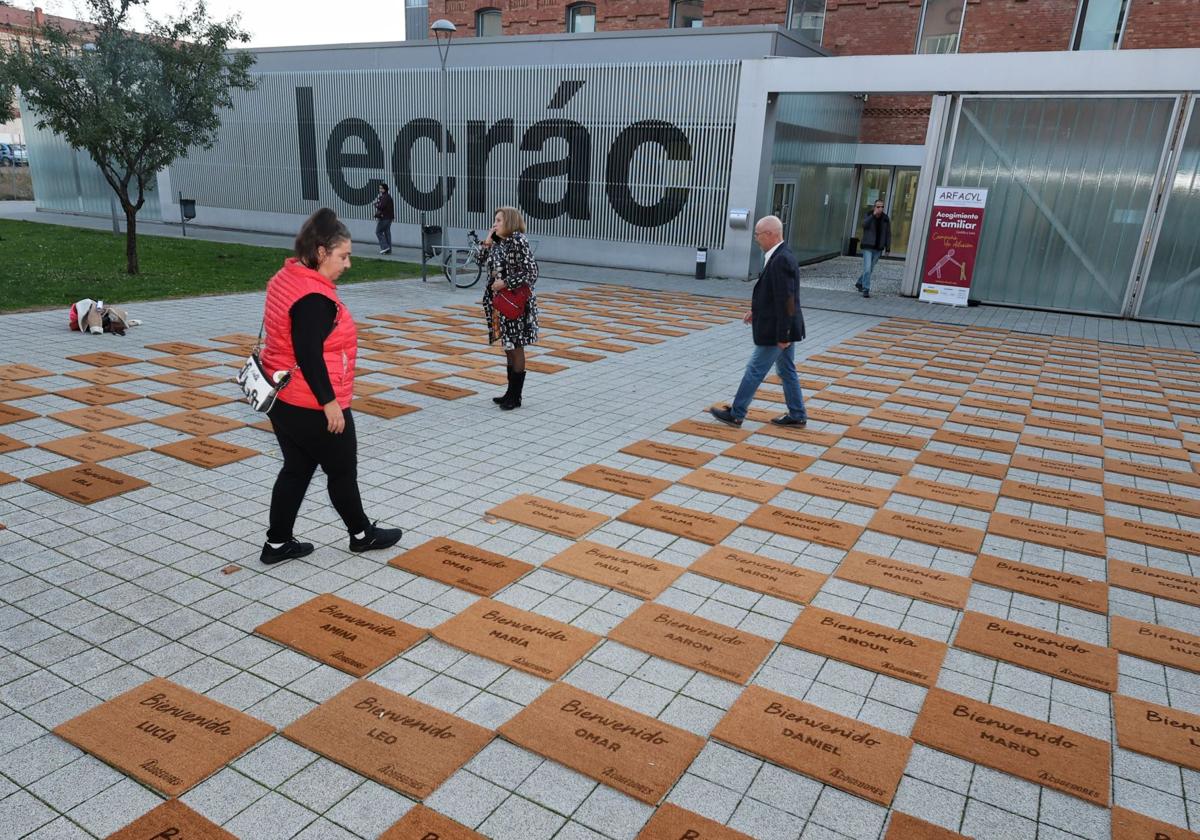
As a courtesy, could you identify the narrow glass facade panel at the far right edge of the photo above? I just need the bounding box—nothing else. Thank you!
[1138,102,1200,324]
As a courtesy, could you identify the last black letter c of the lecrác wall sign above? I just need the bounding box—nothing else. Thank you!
[605,120,691,228]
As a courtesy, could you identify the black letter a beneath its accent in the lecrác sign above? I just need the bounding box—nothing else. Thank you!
[517,119,592,220]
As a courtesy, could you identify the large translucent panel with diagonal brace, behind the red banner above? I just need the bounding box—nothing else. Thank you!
[942,97,1175,314]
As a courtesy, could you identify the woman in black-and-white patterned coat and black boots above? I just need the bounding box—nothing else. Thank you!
[479,206,538,412]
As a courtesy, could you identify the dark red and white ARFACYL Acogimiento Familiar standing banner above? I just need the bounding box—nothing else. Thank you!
[920,187,988,306]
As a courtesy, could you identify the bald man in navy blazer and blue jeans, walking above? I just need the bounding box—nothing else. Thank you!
[709,216,809,427]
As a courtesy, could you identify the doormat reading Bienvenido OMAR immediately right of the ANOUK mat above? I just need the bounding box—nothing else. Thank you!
[954,610,1117,692]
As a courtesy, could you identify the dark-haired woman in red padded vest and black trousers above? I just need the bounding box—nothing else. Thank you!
[259,208,401,564]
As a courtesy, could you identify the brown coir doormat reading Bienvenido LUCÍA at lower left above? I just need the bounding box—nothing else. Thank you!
[54,678,275,797]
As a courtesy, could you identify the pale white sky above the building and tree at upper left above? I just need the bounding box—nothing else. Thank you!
[12,0,404,47]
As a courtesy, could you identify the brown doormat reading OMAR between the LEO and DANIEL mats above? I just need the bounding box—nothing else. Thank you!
[499,683,704,805]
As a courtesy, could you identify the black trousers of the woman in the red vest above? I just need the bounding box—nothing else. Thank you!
[266,401,371,542]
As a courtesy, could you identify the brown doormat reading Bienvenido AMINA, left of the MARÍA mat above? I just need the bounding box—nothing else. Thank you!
[254,595,425,677]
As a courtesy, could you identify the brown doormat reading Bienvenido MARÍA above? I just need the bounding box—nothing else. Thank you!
[431,598,600,679]
